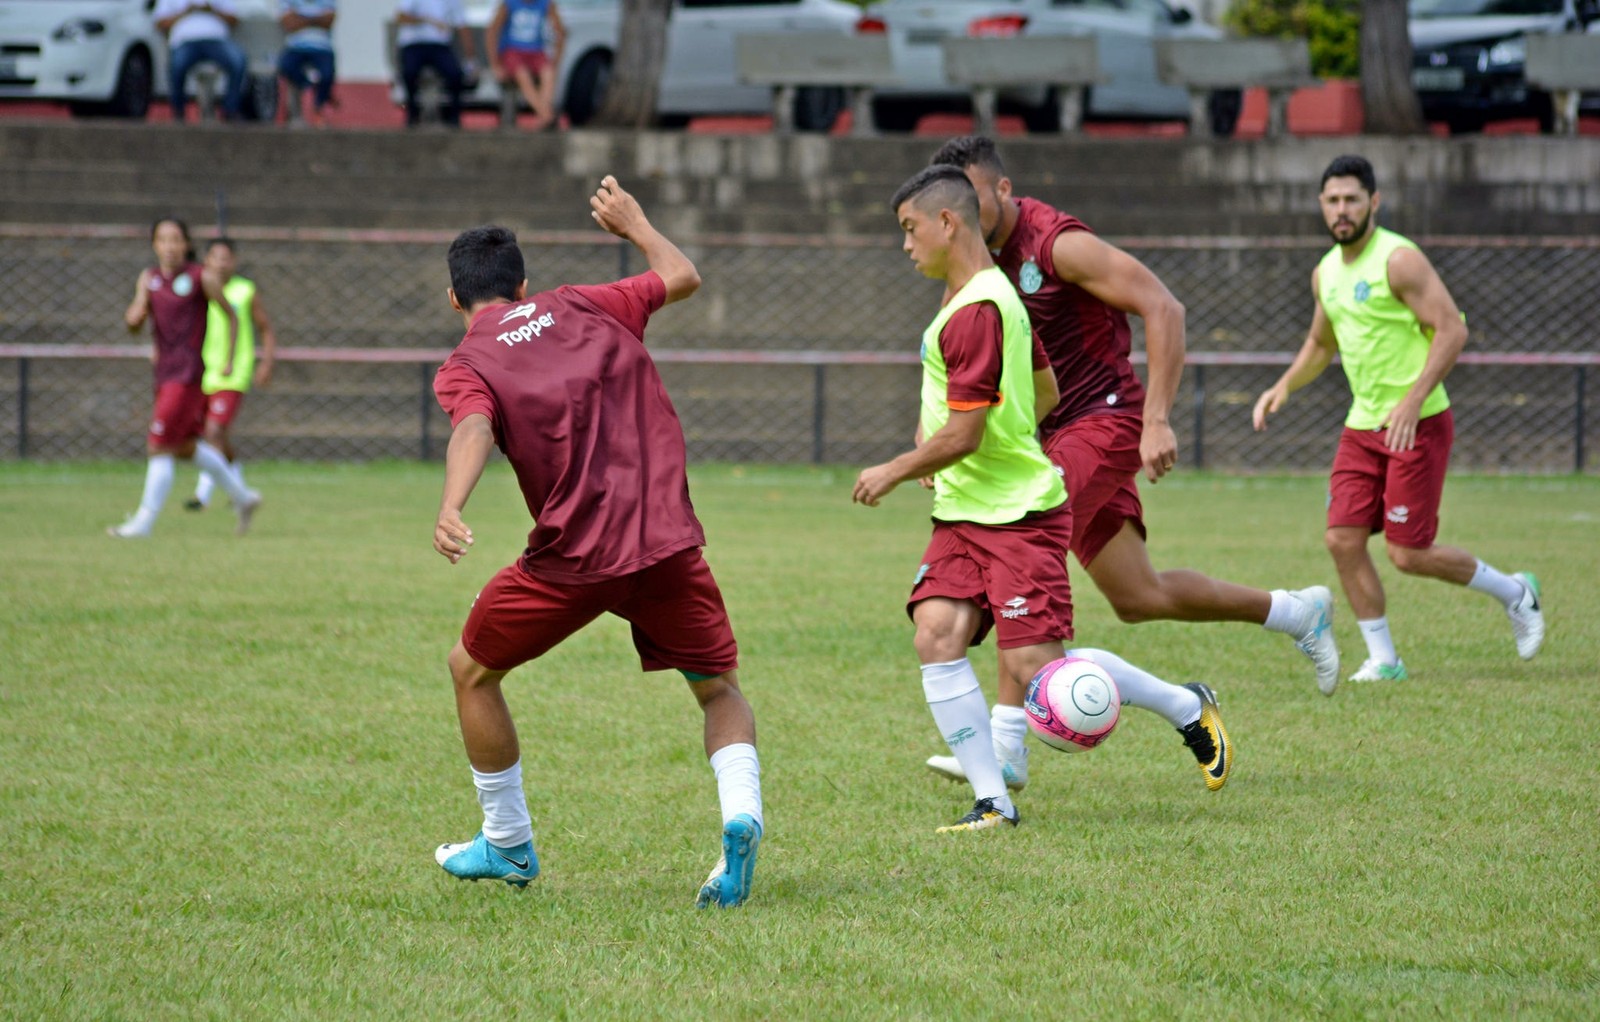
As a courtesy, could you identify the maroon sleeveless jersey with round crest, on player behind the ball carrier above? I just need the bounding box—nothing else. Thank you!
[995,198,1144,433]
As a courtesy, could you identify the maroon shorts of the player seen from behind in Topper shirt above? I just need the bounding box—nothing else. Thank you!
[461,547,739,677]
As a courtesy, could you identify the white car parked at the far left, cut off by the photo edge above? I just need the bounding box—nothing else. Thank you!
[0,0,166,117]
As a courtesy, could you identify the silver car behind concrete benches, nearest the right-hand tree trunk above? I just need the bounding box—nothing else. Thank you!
[862,0,1238,134]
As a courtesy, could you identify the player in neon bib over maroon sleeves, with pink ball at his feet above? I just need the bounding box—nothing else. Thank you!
[851,159,1234,832]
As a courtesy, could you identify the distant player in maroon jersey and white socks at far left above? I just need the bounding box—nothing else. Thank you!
[106,218,261,539]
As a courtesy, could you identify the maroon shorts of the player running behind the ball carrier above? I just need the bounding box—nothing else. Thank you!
[1045,413,1144,566]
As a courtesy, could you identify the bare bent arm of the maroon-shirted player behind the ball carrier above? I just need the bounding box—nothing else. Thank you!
[1050,230,1186,483]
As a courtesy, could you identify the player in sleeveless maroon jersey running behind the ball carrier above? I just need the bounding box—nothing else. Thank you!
[928,136,1339,790]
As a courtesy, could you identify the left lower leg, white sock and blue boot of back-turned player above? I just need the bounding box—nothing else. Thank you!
[434,641,539,888]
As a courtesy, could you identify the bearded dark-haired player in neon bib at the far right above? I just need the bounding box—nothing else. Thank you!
[1253,155,1544,681]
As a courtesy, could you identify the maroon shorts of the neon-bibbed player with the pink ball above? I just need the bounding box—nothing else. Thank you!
[906,507,1072,649]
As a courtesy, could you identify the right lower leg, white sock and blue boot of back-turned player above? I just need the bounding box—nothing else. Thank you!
[688,670,765,908]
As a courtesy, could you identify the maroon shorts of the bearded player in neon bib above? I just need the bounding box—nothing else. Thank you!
[1328,408,1456,550]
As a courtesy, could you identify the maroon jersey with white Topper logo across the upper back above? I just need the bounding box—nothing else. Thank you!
[434,272,706,584]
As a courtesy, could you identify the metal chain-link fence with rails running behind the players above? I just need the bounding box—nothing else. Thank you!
[0,227,1600,472]
